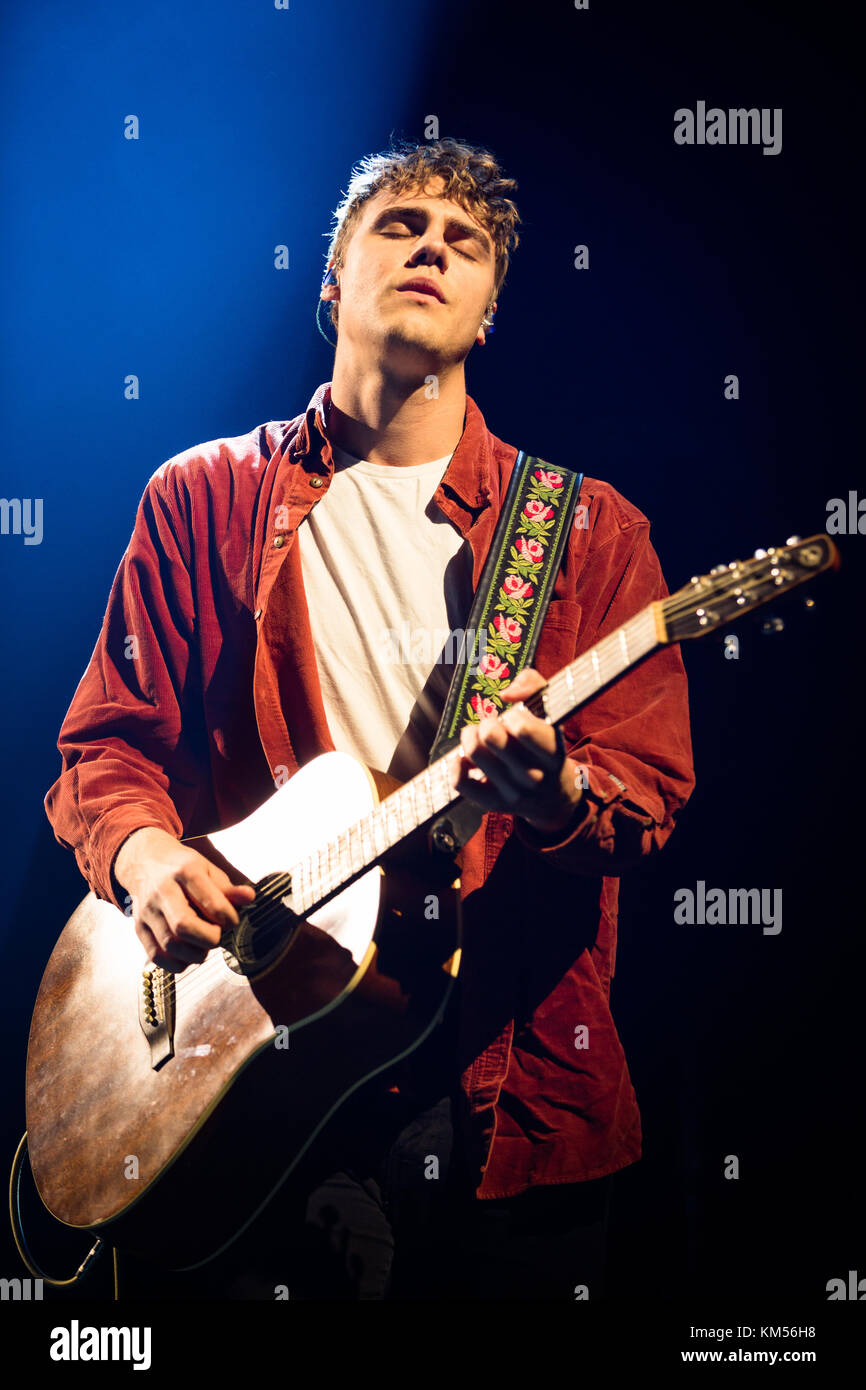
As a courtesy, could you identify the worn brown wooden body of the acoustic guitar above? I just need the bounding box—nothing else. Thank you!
[26,753,460,1269]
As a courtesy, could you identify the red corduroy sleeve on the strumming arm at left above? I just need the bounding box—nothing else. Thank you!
[44,470,207,908]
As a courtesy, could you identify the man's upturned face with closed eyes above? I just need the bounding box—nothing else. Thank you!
[328,178,495,373]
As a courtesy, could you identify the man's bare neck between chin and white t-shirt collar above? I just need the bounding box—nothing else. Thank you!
[328,352,466,467]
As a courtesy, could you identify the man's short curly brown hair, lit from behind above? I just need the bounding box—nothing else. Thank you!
[325,138,520,328]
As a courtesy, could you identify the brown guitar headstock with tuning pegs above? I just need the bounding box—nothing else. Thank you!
[662,534,840,642]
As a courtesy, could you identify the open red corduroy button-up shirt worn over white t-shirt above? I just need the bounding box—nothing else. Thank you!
[44,384,694,1198]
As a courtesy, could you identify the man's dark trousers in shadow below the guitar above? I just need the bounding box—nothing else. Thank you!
[204,1088,610,1301]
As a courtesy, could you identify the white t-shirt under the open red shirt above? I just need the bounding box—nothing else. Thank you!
[297,448,473,781]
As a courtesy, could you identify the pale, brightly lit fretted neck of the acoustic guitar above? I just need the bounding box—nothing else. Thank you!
[291,602,667,916]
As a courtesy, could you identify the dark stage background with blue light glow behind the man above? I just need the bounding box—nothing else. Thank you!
[0,0,866,1300]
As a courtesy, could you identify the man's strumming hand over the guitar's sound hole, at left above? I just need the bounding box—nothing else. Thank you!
[114,826,256,973]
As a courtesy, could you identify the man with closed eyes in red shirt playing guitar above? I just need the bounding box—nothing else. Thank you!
[46,139,694,1300]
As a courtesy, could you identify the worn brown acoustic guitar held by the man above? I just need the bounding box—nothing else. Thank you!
[26,535,838,1269]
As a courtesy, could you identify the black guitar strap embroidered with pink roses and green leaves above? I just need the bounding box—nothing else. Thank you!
[430,450,584,853]
